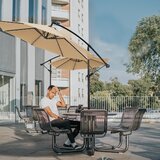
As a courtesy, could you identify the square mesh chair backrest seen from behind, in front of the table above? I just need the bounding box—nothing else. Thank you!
[80,109,107,135]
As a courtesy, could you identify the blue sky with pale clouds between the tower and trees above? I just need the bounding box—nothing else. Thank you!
[89,0,160,84]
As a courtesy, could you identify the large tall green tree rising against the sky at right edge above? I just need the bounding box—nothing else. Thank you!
[127,16,160,88]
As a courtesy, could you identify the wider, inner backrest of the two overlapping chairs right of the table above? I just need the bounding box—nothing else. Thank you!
[120,107,138,130]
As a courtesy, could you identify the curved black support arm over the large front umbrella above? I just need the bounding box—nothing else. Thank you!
[50,21,109,68]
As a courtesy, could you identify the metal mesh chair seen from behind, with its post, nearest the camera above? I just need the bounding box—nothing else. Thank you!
[80,109,107,155]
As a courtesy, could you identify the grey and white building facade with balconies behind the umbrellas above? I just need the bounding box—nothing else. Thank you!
[0,0,89,121]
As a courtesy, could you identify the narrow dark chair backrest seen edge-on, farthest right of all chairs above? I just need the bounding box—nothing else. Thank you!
[132,108,146,131]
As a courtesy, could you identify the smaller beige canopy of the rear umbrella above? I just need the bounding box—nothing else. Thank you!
[51,56,108,70]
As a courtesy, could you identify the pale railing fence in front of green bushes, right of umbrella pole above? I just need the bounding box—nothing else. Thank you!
[90,96,160,112]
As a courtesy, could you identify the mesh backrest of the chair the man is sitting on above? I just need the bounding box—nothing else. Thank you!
[34,108,51,131]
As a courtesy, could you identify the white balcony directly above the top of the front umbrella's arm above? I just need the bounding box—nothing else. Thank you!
[51,8,69,20]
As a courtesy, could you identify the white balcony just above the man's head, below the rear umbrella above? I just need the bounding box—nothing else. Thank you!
[52,78,69,87]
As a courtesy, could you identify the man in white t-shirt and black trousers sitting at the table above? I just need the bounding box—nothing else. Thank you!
[40,85,80,149]
